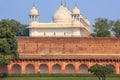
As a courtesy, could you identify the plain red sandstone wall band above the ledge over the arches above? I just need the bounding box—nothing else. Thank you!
[17,37,120,54]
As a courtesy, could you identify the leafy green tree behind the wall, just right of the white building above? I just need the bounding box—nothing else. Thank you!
[92,18,113,37]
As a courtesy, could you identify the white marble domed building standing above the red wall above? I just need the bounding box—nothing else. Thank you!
[28,5,90,37]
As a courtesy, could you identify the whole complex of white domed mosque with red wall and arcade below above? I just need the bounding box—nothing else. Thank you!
[0,4,120,74]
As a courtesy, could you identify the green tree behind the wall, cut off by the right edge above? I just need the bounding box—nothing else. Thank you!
[112,20,120,37]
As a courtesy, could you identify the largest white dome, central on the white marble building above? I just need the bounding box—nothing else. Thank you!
[53,5,72,23]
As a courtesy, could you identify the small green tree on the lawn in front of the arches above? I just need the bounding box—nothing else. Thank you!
[89,64,114,80]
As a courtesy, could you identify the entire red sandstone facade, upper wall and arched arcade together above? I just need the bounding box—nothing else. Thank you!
[1,37,120,74]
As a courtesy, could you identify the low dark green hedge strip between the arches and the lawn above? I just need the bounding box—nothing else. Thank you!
[8,74,120,77]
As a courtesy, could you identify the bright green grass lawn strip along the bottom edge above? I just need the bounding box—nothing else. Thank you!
[0,77,120,80]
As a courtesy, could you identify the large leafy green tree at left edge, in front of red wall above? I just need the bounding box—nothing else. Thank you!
[0,19,19,58]
